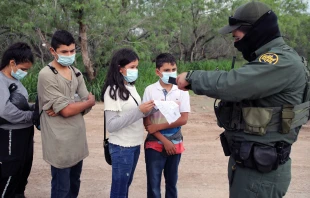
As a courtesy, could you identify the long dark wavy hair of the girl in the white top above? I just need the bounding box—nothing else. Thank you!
[101,48,139,101]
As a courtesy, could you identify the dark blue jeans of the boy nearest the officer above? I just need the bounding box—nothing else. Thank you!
[145,149,181,198]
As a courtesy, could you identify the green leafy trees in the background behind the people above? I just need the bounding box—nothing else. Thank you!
[0,0,310,68]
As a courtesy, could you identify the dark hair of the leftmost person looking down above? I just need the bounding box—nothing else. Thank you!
[0,42,34,70]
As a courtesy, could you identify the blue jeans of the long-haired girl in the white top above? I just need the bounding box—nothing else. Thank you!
[109,143,140,198]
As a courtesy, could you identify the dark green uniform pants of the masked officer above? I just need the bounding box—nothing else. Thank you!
[228,157,291,198]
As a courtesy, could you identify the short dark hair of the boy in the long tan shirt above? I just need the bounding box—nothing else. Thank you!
[51,30,75,51]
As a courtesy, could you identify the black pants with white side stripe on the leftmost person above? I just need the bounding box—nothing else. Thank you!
[0,126,34,197]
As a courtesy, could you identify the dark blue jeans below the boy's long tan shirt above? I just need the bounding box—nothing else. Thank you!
[51,160,83,198]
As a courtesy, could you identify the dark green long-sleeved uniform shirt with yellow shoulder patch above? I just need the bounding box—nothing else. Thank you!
[188,37,306,144]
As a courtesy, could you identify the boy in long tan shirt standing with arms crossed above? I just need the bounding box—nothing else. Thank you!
[38,30,95,198]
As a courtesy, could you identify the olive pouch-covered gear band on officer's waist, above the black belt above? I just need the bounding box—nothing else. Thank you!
[220,101,310,135]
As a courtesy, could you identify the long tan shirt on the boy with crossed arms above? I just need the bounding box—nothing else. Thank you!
[38,66,89,168]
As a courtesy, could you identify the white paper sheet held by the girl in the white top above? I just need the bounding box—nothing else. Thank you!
[154,100,181,124]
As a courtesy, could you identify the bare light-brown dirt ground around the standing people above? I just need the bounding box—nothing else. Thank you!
[26,96,310,198]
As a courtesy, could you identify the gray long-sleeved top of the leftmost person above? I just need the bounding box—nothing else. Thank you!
[0,71,33,130]
